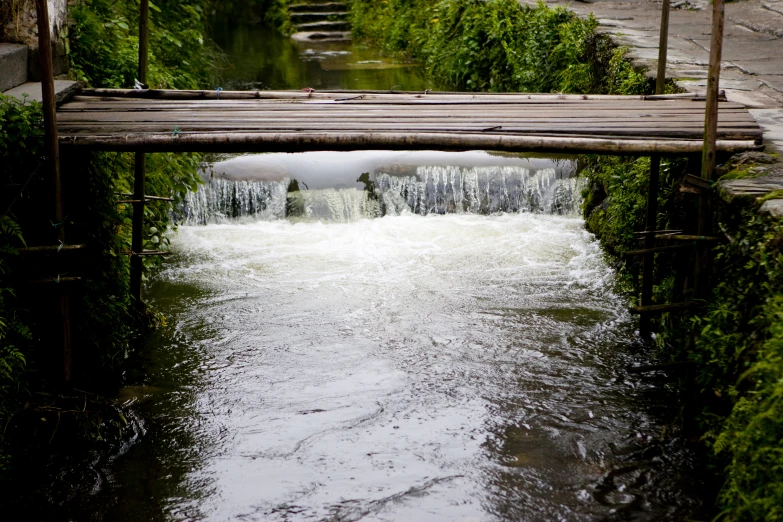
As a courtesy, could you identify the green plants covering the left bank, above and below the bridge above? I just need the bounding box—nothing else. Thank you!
[0,0,207,470]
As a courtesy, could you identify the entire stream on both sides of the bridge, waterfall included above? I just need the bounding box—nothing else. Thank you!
[15,18,701,521]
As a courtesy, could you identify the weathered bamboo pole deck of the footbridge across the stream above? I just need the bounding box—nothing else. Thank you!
[57,89,761,155]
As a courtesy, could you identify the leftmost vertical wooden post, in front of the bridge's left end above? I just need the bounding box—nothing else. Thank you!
[35,0,73,382]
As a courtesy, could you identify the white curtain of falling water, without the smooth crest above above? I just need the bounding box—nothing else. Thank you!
[179,166,583,225]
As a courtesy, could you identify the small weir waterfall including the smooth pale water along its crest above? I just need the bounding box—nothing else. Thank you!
[180,152,583,225]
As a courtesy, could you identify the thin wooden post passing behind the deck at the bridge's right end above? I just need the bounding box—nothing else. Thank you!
[639,0,671,337]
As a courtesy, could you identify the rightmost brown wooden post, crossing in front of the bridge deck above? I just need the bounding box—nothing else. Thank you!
[694,0,725,298]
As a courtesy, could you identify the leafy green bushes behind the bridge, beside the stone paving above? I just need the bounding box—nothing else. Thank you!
[351,0,651,94]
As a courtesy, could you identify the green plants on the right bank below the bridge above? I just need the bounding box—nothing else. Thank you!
[584,158,783,520]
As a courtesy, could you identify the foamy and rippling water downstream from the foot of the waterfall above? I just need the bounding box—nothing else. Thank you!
[138,213,691,521]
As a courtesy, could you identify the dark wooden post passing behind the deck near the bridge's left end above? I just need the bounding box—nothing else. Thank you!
[130,0,150,313]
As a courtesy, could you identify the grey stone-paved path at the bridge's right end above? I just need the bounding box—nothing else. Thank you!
[520,0,783,211]
